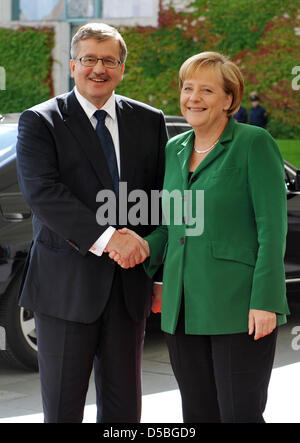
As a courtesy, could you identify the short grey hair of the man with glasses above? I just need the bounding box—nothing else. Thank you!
[71,23,127,63]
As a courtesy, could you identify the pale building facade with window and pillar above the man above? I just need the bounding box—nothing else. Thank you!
[0,0,163,95]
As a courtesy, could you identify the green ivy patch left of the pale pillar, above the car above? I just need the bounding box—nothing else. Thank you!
[0,28,54,114]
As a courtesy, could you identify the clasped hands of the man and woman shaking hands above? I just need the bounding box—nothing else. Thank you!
[104,228,150,269]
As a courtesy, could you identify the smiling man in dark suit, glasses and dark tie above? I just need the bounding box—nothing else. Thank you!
[17,23,167,422]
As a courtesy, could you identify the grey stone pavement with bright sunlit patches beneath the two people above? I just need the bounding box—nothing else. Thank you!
[0,299,300,423]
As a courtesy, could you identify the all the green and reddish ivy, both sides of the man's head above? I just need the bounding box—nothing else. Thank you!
[0,0,300,139]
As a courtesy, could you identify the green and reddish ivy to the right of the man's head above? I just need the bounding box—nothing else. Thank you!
[118,0,300,139]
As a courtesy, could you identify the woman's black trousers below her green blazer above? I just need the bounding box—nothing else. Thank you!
[166,309,277,423]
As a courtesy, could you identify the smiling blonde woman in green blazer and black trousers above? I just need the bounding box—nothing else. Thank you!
[109,52,289,422]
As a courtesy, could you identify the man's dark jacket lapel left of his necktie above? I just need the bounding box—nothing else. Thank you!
[63,92,114,190]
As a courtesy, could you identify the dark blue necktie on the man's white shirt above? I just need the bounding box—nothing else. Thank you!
[94,110,119,197]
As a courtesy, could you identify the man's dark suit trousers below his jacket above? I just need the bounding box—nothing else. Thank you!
[35,272,145,423]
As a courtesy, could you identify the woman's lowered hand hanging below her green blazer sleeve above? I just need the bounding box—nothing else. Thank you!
[248,309,277,340]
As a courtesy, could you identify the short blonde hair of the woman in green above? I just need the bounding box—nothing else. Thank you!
[179,51,244,117]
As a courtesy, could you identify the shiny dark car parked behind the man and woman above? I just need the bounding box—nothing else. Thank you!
[0,116,300,370]
